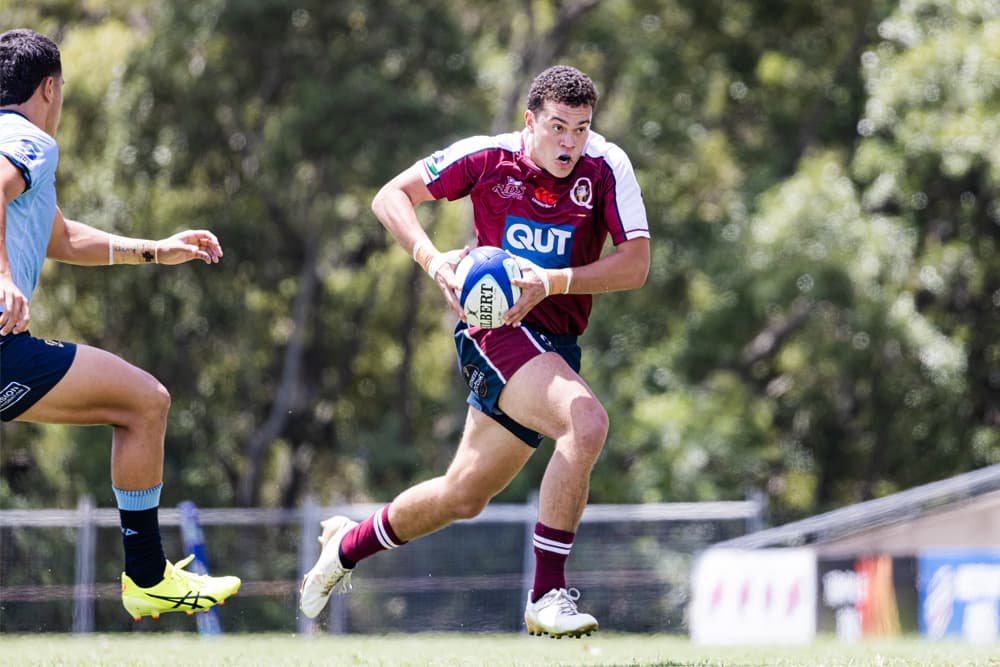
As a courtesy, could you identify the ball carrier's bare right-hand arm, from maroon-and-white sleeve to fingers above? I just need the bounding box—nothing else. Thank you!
[503,238,649,324]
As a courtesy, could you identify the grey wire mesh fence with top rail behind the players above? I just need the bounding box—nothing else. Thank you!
[0,497,763,633]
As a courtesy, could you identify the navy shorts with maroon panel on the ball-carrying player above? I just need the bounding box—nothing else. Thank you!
[455,321,581,447]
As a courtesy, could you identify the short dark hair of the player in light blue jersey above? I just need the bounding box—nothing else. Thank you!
[0,28,62,106]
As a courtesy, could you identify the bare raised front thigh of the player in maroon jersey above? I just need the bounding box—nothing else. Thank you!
[499,352,605,438]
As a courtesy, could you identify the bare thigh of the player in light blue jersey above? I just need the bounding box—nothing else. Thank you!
[17,345,170,425]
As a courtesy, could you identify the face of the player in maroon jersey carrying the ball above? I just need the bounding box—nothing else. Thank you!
[524,100,594,178]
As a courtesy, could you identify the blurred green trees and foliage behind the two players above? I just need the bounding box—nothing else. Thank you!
[0,0,1000,522]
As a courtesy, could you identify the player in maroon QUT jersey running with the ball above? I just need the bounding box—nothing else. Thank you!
[300,66,649,637]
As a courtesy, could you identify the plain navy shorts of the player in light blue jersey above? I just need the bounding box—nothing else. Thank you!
[0,331,76,422]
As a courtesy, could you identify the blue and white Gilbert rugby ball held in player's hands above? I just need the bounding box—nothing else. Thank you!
[455,246,521,329]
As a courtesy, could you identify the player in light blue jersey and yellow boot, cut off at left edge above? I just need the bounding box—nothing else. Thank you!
[0,29,240,620]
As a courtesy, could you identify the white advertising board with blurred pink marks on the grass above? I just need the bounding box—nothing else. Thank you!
[689,549,816,644]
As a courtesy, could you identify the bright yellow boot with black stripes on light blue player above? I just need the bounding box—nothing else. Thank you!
[122,554,240,621]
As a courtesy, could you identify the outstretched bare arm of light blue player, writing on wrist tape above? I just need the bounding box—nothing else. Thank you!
[46,207,222,266]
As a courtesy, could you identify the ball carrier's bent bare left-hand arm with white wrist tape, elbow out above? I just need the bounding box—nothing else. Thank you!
[372,163,465,319]
